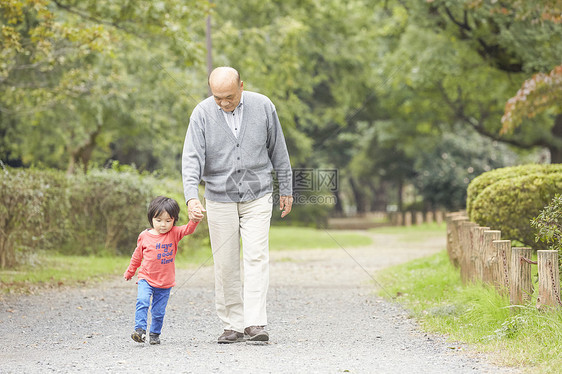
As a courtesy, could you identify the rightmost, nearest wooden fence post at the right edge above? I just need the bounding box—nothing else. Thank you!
[537,251,562,309]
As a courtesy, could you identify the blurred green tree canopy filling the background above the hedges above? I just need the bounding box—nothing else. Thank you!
[0,0,562,213]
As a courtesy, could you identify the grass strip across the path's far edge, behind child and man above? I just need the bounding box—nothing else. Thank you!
[0,226,371,294]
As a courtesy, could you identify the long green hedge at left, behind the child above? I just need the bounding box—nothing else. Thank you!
[0,169,207,268]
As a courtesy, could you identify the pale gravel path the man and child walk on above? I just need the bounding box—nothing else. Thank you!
[0,234,517,373]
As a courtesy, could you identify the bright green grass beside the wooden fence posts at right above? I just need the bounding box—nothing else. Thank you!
[377,251,562,373]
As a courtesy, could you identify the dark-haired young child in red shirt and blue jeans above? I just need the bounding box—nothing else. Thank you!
[123,196,199,344]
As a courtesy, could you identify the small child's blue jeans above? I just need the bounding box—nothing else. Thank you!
[135,279,171,334]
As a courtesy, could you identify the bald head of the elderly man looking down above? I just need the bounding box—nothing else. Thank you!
[209,66,244,112]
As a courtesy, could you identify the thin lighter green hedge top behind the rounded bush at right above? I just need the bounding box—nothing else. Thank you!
[466,164,562,217]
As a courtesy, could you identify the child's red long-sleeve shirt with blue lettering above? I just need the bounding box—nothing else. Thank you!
[124,221,199,288]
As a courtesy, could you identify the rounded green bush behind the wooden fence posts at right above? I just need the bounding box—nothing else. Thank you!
[469,165,562,250]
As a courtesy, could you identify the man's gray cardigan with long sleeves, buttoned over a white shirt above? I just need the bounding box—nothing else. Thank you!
[182,91,292,202]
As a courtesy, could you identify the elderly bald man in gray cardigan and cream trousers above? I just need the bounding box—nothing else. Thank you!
[182,67,293,343]
